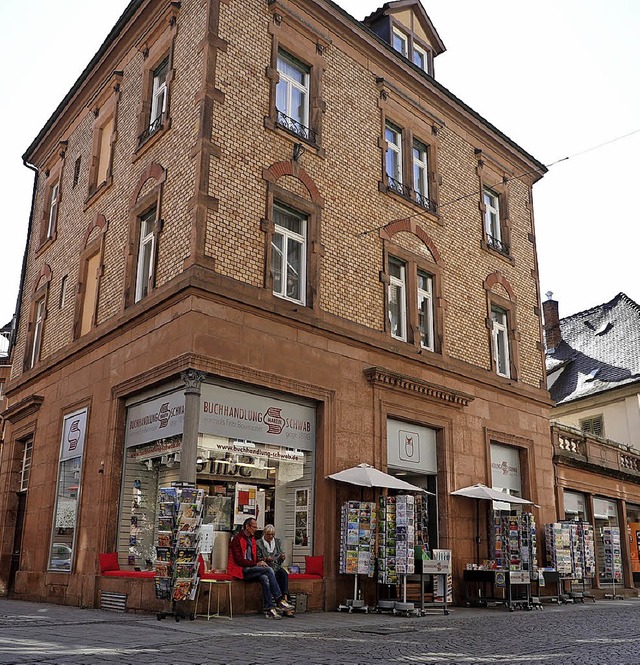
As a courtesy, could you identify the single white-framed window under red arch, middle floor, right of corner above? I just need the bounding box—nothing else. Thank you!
[271,205,307,305]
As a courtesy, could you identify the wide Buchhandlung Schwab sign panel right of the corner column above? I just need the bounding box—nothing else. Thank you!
[199,384,316,452]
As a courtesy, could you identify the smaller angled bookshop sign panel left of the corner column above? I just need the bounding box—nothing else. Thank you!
[124,390,184,448]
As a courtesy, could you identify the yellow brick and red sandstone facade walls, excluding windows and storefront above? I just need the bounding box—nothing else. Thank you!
[0,0,554,607]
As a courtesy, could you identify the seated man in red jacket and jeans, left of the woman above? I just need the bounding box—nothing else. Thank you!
[227,517,293,619]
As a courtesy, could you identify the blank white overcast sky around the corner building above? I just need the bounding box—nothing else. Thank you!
[0,0,640,325]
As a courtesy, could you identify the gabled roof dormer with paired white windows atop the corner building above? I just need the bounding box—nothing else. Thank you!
[363,0,446,76]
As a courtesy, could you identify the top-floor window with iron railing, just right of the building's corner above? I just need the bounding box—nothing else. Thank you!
[276,50,315,142]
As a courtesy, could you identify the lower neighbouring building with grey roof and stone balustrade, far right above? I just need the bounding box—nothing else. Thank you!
[543,293,640,587]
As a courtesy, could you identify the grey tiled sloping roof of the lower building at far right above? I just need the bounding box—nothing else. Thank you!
[547,293,640,404]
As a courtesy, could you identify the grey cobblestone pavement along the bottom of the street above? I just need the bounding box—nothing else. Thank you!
[0,599,640,665]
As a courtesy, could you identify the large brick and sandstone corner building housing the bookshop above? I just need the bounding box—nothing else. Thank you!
[0,0,555,610]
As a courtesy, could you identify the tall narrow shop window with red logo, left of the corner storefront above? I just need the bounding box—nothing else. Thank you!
[48,409,87,573]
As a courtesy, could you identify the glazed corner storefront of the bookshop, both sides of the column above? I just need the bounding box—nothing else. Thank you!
[118,383,316,571]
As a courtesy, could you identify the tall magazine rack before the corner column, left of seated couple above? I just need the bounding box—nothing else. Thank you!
[154,483,204,621]
